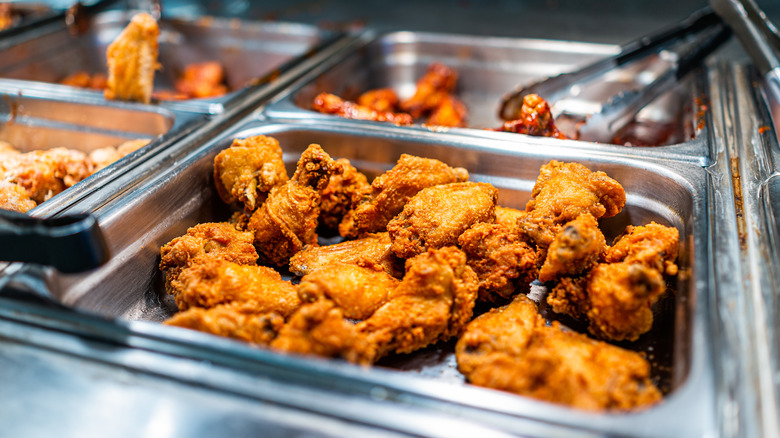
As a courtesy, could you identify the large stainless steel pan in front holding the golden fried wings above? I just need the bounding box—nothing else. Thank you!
[39,119,716,436]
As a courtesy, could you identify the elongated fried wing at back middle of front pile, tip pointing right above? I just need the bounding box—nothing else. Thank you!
[339,154,469,238]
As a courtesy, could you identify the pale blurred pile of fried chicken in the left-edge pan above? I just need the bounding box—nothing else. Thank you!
[0,139,149,213]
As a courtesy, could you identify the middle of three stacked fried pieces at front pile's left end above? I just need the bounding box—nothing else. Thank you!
[172,259,301,317]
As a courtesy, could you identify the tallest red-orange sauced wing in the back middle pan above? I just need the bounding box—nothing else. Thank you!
[401,62,458,119]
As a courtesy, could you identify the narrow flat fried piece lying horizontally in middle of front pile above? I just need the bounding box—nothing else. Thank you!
[289,232,404,278]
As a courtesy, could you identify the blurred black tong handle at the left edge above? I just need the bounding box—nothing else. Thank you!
[0,210,109,273]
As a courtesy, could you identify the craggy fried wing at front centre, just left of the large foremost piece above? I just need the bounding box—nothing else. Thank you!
[357,246,479,361]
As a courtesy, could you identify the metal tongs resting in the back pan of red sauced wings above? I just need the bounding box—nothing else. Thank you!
[499,7,731,141]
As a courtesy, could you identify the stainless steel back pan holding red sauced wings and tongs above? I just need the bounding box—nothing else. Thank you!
[267,32,708,157]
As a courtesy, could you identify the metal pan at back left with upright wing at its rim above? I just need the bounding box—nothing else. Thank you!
[0,11,334,112]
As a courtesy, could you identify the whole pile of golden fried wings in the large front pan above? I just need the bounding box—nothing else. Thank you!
[160,136,678,410]
